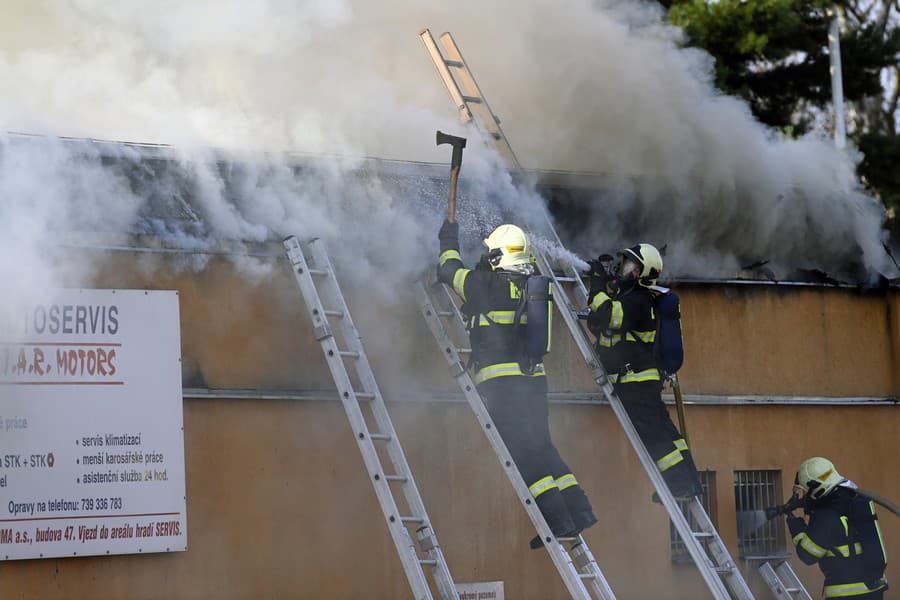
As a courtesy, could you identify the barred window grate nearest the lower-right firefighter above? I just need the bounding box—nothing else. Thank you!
[734,471,786,560]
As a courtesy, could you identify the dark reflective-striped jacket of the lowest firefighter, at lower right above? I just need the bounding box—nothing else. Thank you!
[788,486,887,598]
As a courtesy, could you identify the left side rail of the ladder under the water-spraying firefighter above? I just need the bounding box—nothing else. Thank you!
[536,253,753,600]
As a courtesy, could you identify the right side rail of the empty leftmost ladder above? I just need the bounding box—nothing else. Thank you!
[309,239,459,600]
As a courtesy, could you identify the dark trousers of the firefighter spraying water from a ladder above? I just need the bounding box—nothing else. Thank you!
[615,380,703,497]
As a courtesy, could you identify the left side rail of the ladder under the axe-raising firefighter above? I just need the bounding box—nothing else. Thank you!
[416,282,614,600]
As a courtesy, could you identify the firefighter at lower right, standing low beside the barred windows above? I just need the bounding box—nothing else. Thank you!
[787,456,888,600]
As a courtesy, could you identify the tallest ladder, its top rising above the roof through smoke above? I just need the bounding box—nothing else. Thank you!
[419,29,808,600]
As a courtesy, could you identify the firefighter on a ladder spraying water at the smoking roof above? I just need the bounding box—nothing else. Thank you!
[587,244,702,498]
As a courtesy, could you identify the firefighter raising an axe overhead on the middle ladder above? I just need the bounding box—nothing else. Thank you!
[438,221,597,548]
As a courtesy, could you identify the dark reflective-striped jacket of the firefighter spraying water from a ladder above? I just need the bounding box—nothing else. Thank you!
[587,284,660,383]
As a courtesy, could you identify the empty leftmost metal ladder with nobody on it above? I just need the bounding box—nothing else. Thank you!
[284,236,459,600]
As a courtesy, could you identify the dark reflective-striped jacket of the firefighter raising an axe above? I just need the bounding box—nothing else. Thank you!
[438,229,544,384]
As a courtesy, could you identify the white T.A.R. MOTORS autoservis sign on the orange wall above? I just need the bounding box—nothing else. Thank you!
[0,290,187,560]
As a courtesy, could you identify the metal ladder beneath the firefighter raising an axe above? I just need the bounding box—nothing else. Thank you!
[417,283,615,600]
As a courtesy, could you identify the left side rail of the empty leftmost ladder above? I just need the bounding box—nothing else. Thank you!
[284,236,432,600]
